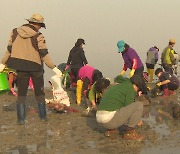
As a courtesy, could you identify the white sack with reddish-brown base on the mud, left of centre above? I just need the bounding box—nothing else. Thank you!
[46,75,70,112]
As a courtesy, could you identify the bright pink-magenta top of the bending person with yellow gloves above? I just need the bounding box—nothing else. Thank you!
[78,65,95,83]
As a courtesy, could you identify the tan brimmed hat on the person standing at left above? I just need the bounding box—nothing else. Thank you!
[26,14,46,28]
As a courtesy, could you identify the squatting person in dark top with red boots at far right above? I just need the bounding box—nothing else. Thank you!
[155,68,180,98]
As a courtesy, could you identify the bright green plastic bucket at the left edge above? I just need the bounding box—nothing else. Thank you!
[0,72,10,94]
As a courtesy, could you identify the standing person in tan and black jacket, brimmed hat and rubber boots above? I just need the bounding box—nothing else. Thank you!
[0,14,62,125]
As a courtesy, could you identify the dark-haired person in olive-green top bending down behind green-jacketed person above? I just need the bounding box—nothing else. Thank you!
[82,78,110,116]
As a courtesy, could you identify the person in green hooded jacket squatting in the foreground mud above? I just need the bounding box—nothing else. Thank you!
[95,75,144,141]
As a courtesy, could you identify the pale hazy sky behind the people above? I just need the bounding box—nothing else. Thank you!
[0,0,180,83]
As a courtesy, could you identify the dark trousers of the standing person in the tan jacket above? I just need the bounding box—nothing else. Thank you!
[17,71,45,103]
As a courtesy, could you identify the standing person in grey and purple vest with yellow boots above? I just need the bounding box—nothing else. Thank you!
[146,46,159,83]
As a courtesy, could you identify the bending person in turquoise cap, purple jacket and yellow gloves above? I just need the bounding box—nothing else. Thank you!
[117,40,148,94]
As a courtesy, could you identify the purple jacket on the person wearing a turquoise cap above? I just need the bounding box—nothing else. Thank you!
[122,48,143,69]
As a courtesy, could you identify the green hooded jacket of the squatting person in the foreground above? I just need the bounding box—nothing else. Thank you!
[98,76,136,111]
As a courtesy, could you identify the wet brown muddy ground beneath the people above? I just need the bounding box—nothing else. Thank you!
[0,89,180,154]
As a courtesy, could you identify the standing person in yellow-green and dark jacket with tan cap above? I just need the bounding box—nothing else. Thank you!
[161,39,176,74]
